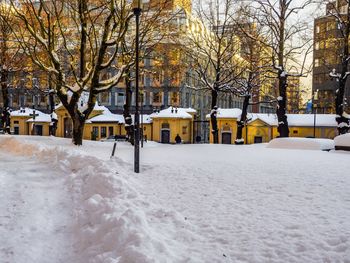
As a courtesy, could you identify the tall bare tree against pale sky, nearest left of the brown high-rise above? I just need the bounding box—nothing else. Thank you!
[254,0,313,137]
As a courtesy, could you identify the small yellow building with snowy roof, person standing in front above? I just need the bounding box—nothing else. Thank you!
[151,107,196,143]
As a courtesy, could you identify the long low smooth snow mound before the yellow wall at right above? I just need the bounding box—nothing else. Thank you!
[267,138,334,150]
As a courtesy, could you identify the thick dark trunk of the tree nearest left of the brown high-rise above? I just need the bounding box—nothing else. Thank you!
[276,70,289,137]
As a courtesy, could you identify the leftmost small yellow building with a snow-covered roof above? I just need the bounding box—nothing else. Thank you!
[11,108,51,136]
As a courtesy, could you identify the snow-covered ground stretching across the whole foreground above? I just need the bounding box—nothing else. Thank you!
[0,136,350,263]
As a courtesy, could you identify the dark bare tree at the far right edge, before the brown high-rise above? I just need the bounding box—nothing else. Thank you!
[326,0,350,134]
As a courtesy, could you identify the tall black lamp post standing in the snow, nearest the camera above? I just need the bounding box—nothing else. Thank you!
[133,3,141,173]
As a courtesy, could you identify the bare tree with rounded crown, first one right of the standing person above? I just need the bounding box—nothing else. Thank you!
[185,0,244,143]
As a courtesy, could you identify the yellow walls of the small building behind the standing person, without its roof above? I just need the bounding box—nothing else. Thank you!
[152,118,193,143]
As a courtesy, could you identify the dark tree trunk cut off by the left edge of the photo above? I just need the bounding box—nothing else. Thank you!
[1,70,11,134]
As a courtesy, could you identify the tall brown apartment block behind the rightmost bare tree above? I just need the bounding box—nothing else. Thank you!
[312,0,350,113]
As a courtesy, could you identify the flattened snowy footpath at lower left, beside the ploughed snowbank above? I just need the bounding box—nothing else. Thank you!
[0,147,75,263]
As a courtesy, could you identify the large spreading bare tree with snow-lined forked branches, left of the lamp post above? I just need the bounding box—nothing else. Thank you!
[11,0,134,145]
